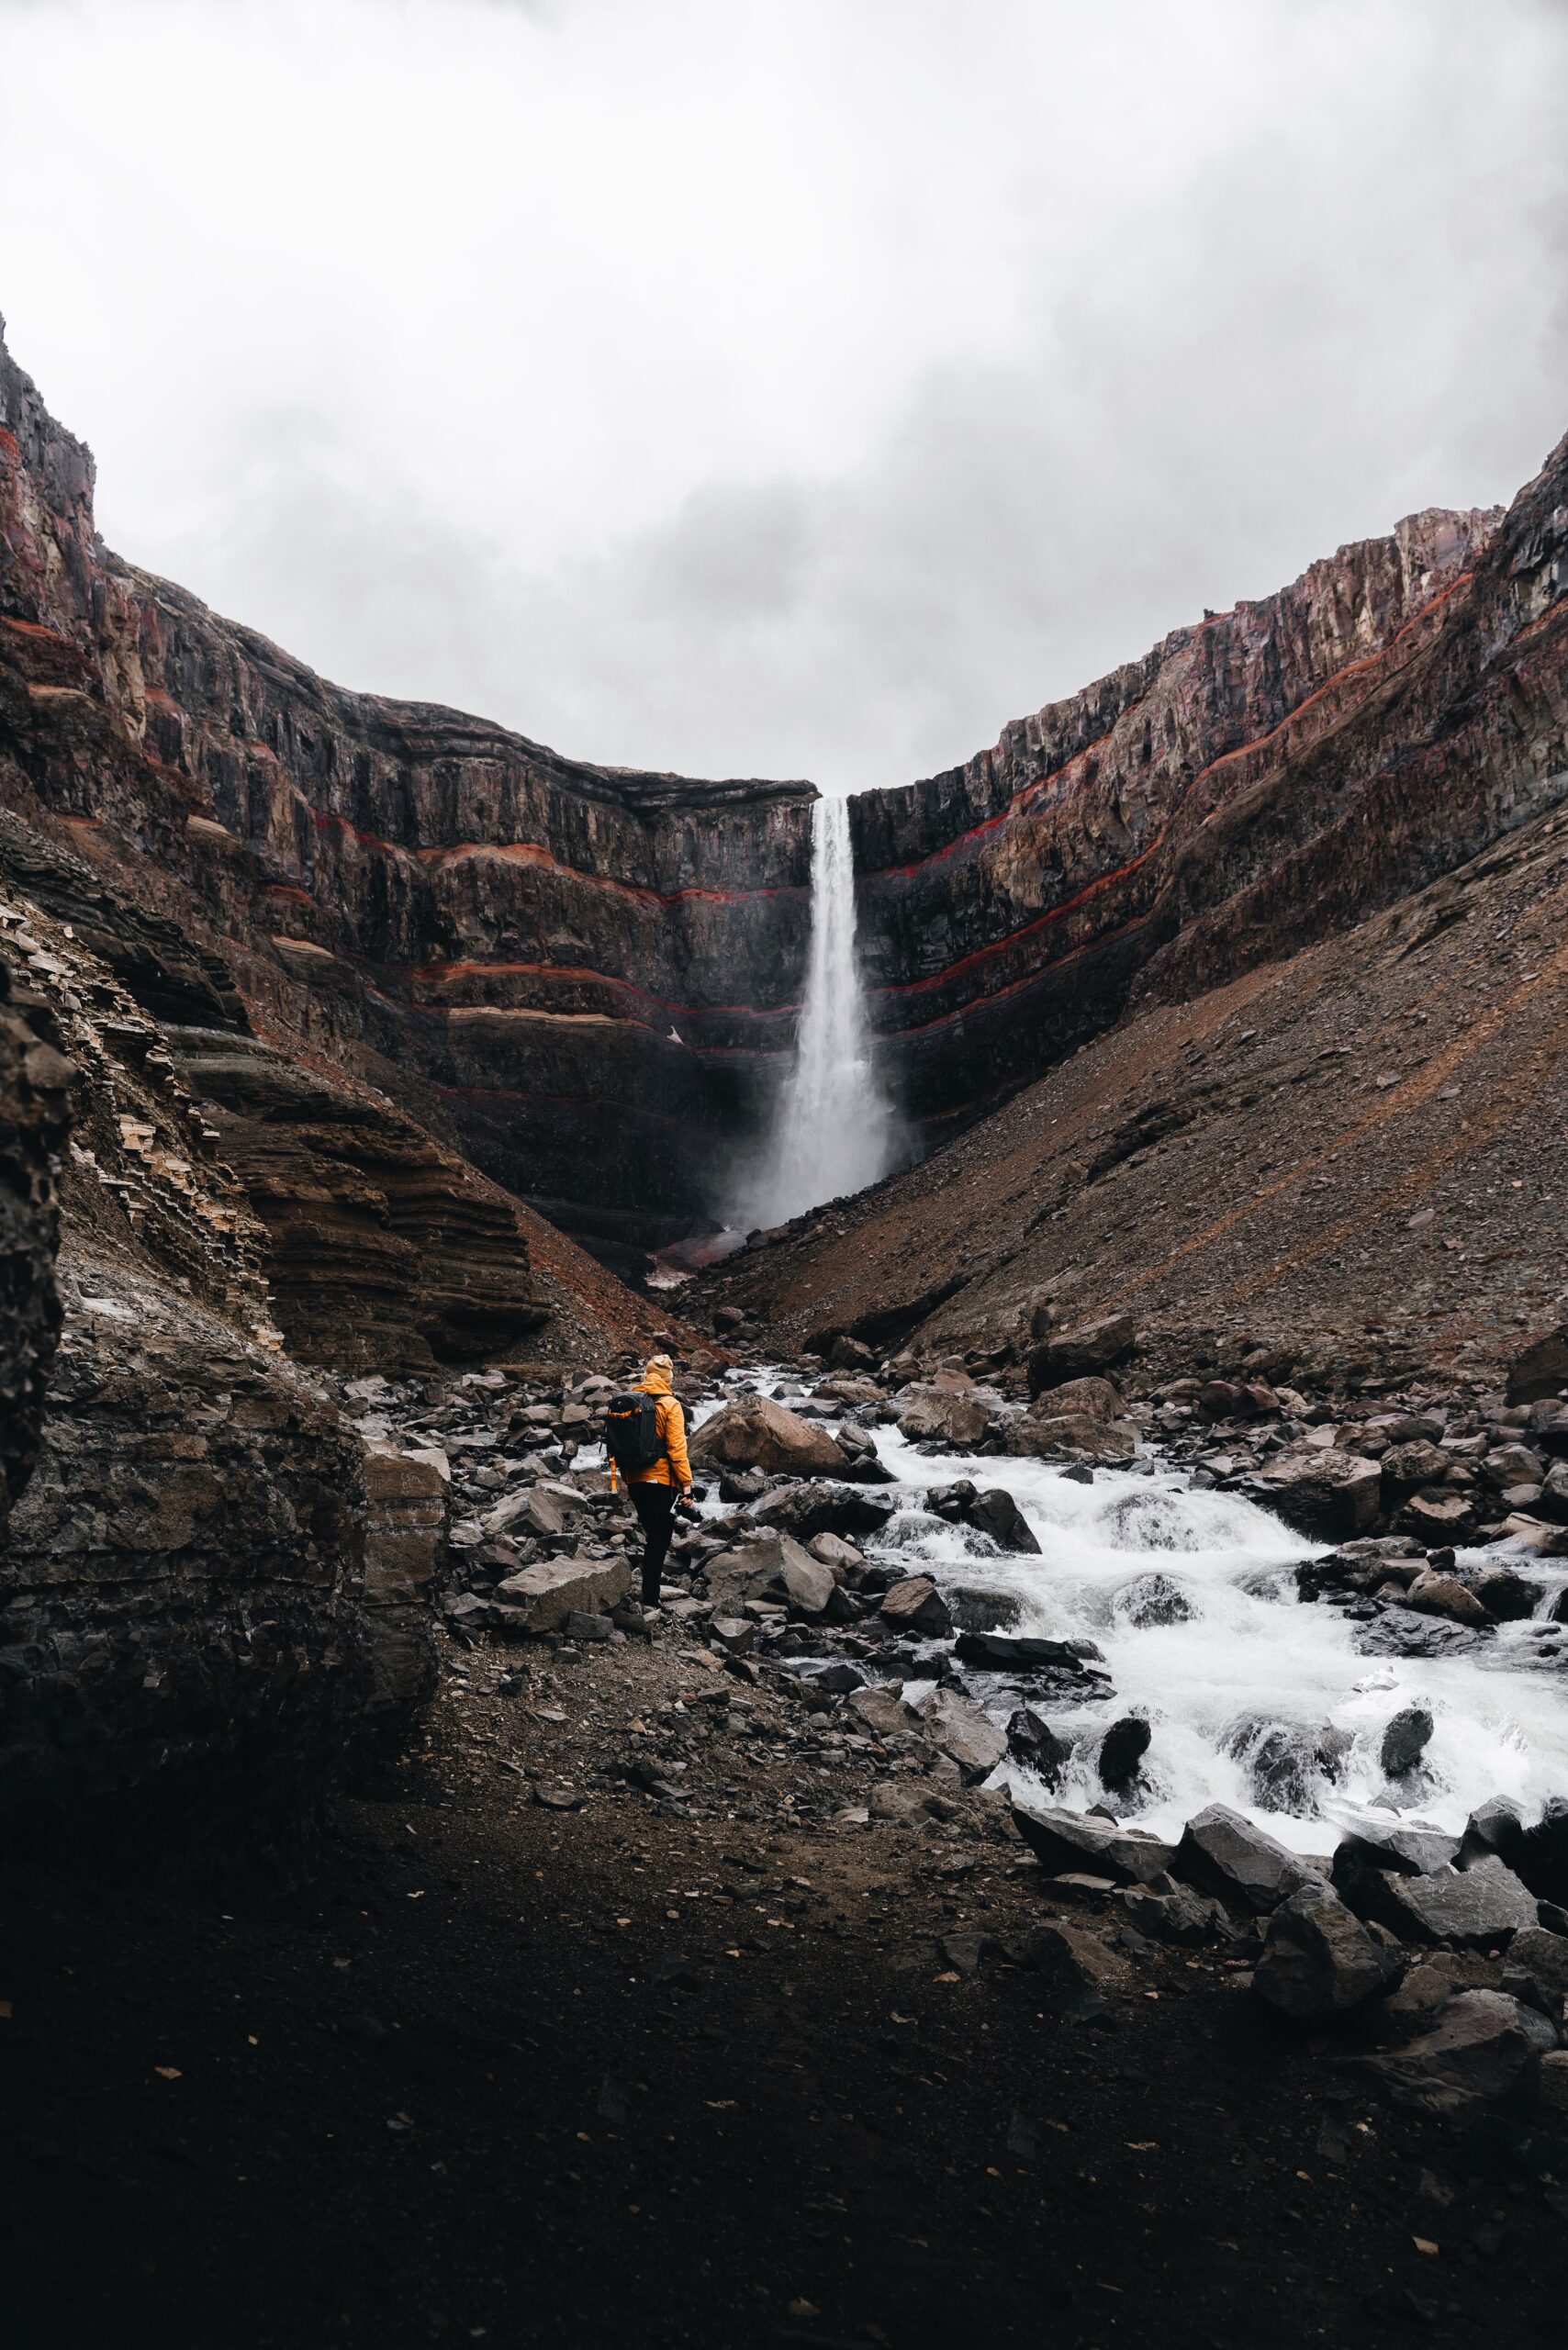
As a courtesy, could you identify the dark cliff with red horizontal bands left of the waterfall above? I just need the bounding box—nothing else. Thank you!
[0,326,816,1269]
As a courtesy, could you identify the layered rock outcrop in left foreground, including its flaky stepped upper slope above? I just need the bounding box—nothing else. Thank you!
[0,865,454,1821]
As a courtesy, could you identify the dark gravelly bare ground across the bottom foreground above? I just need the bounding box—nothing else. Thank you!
[0,1642,1568,2350]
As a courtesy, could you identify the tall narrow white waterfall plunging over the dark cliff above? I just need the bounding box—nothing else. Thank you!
[741,799,898,1225]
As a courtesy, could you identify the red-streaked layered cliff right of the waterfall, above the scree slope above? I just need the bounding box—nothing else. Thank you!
[854,476,1568,1135]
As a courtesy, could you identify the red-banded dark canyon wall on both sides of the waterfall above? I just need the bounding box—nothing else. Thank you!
[0,321,1568,1264]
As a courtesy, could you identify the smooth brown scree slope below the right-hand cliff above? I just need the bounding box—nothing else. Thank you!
[703,809,1568,1389]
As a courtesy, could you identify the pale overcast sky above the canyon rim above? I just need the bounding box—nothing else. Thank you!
[0,0,1568,789]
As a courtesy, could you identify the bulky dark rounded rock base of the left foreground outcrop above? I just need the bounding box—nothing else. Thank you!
[0,1264,444,1809]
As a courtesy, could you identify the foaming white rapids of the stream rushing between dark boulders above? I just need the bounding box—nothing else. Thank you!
[695,1380,1568,1852]
